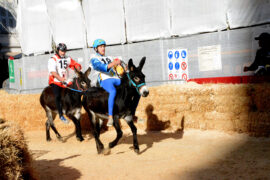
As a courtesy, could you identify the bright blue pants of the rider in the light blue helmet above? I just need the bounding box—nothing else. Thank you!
[100,78,121,116]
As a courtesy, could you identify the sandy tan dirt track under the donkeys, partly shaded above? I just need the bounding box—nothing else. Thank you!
[25,129,270,180]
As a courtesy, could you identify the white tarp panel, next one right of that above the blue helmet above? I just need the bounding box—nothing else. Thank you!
[124,0,170,42]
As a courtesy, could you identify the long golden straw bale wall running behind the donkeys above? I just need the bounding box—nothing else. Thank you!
[0,83,270,135]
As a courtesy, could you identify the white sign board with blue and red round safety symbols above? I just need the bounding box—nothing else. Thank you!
[167,48,188,81]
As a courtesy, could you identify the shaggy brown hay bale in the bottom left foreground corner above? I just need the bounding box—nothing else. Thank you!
[0,120,36,179]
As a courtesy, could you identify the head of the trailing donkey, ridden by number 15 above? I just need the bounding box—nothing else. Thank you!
[74,67,91,91]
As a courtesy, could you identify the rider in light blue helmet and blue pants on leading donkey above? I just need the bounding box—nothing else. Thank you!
[90,39,121,126]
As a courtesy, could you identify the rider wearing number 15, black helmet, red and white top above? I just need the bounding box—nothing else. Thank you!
[48,43,82,124]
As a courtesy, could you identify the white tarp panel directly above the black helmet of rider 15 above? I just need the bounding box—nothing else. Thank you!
[46,0,86,49]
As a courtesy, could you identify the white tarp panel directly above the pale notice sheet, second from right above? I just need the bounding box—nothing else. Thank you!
[170,0,227,36]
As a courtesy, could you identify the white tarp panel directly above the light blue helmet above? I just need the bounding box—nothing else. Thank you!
[83,0,126,46]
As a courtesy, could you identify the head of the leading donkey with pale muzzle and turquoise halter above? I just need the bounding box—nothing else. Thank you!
[127,57,149,97]
